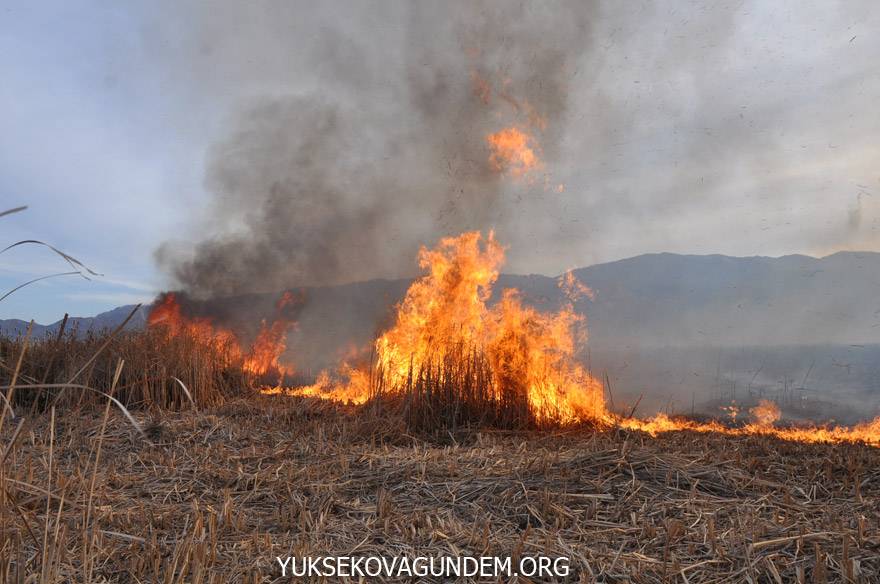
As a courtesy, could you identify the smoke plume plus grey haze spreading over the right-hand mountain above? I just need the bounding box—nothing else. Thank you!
[151,2,880,296]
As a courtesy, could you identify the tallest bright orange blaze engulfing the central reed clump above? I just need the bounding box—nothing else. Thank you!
[278,232,606,423]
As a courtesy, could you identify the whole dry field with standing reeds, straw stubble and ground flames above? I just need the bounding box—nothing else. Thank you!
[0,232,880,582]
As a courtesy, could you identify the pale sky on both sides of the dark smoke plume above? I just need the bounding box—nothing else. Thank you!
[0,0,880,323]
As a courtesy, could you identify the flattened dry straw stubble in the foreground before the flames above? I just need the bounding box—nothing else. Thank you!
[0,395,880,583]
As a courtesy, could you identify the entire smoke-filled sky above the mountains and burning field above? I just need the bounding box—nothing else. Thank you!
[0,0,880,323]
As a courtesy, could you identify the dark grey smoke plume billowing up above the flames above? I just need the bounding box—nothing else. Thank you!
[156,1,595,297]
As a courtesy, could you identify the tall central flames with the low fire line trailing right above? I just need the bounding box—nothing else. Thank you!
[266,232,880,447]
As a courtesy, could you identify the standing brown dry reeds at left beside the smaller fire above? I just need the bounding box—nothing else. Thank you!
[0,320,253,412]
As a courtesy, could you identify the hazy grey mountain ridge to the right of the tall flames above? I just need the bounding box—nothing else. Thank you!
[575,252,880,346]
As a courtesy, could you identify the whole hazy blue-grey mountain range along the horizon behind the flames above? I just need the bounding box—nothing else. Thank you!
[0,252,880,347]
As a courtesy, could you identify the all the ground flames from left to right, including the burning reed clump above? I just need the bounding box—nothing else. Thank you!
[150,232,880,446]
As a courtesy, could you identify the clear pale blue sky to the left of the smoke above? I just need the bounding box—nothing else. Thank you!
[0,3,203,322]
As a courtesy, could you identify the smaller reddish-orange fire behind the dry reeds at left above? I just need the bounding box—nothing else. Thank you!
[147,292,294,376]
